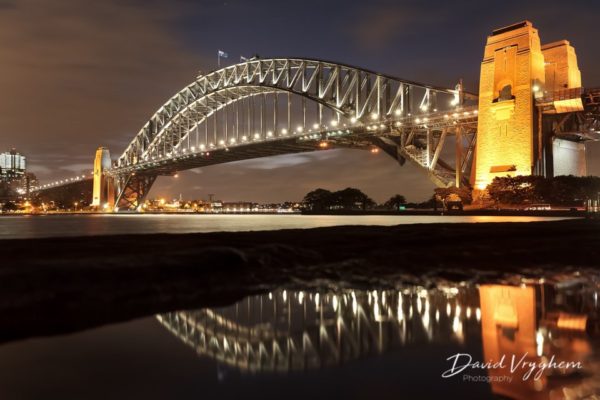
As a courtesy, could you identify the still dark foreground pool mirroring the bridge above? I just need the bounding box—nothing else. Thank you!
[0,275,600,399]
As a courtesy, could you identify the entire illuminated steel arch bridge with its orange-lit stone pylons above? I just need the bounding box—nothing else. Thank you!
[35,21,600,210]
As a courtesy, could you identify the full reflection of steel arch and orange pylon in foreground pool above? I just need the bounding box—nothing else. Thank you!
[157,278,600,399]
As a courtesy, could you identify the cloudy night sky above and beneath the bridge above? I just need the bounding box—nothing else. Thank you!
[0,0,600,202]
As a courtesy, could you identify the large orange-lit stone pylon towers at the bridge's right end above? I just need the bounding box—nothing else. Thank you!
[474,21,587,191]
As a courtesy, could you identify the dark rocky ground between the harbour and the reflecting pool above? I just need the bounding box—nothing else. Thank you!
[0,220,600,341]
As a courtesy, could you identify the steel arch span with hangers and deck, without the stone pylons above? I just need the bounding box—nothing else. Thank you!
[111,58,476,208]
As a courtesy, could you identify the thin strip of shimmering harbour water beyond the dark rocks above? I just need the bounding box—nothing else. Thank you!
[0,214,564,239]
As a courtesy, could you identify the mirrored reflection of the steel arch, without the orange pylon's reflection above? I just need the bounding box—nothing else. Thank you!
[157,288,481,373]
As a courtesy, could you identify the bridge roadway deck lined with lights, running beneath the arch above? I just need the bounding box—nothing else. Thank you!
[110,107,477,184]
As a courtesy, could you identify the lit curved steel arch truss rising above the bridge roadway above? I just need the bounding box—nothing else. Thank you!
[116,58,457,170]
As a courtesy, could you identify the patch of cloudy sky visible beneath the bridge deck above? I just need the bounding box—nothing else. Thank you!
[153,149,434,202]
